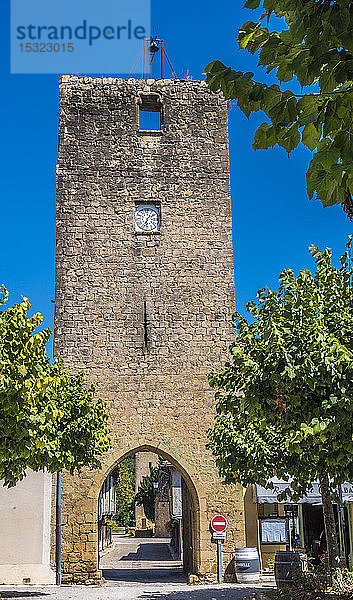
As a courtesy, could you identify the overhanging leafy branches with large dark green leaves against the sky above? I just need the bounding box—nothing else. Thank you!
[205,0,353,218]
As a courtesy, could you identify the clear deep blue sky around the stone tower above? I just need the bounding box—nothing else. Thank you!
[0,0,353,356]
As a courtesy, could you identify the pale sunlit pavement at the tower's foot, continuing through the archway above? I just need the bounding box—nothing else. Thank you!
[0,538,272,600]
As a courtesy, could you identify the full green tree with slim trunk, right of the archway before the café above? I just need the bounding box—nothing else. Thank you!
[209,240,353,568]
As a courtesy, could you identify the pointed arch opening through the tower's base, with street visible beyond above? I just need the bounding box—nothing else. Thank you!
[98,450,197,582]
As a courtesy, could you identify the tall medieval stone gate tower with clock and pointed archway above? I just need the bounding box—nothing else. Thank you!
[55,76,244,582]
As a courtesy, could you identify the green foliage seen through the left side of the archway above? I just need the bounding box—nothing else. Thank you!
[114,456,135,527]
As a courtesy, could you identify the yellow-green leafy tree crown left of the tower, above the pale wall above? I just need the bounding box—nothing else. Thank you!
[0,286,110,486]
